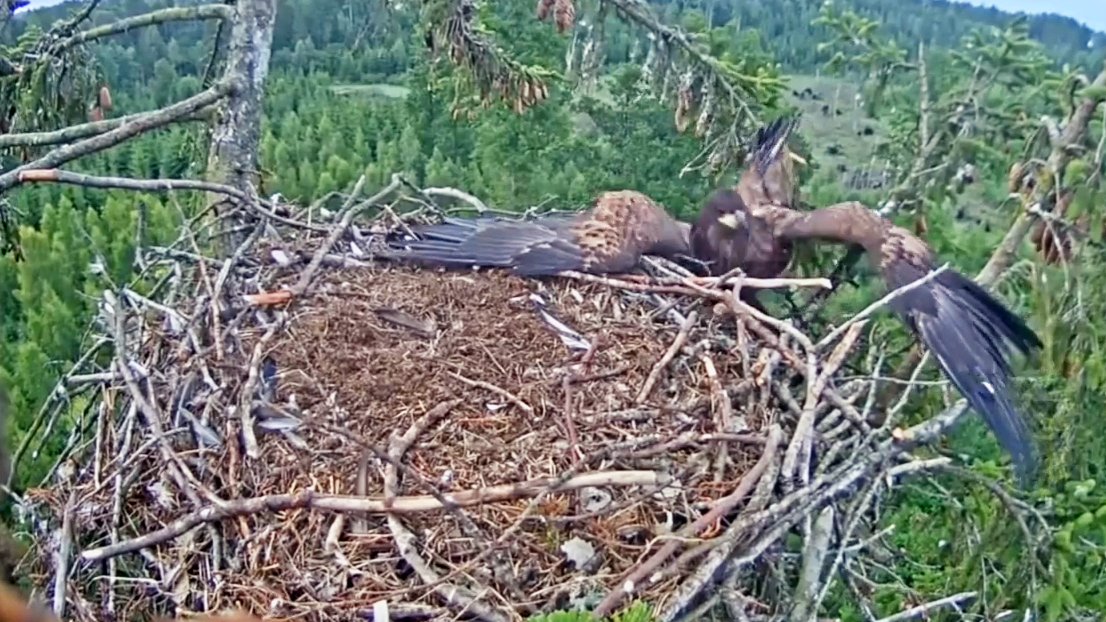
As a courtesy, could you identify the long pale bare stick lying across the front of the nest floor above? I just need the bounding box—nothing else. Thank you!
[81,470,667,561]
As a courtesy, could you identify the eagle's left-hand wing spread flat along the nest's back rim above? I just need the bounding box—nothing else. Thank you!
[390,190,690,276]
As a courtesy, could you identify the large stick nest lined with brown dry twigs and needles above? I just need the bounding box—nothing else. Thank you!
[15,177,968,621]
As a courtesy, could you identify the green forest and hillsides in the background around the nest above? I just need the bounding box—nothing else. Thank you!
[0,0,1106,620]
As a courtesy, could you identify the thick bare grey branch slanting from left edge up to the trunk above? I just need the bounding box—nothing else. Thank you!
[0,81,232,193]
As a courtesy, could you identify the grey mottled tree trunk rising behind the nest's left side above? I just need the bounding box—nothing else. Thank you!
[207,0,277,255]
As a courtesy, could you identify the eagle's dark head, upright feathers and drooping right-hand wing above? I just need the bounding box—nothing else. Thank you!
[690,120,1042,481]
